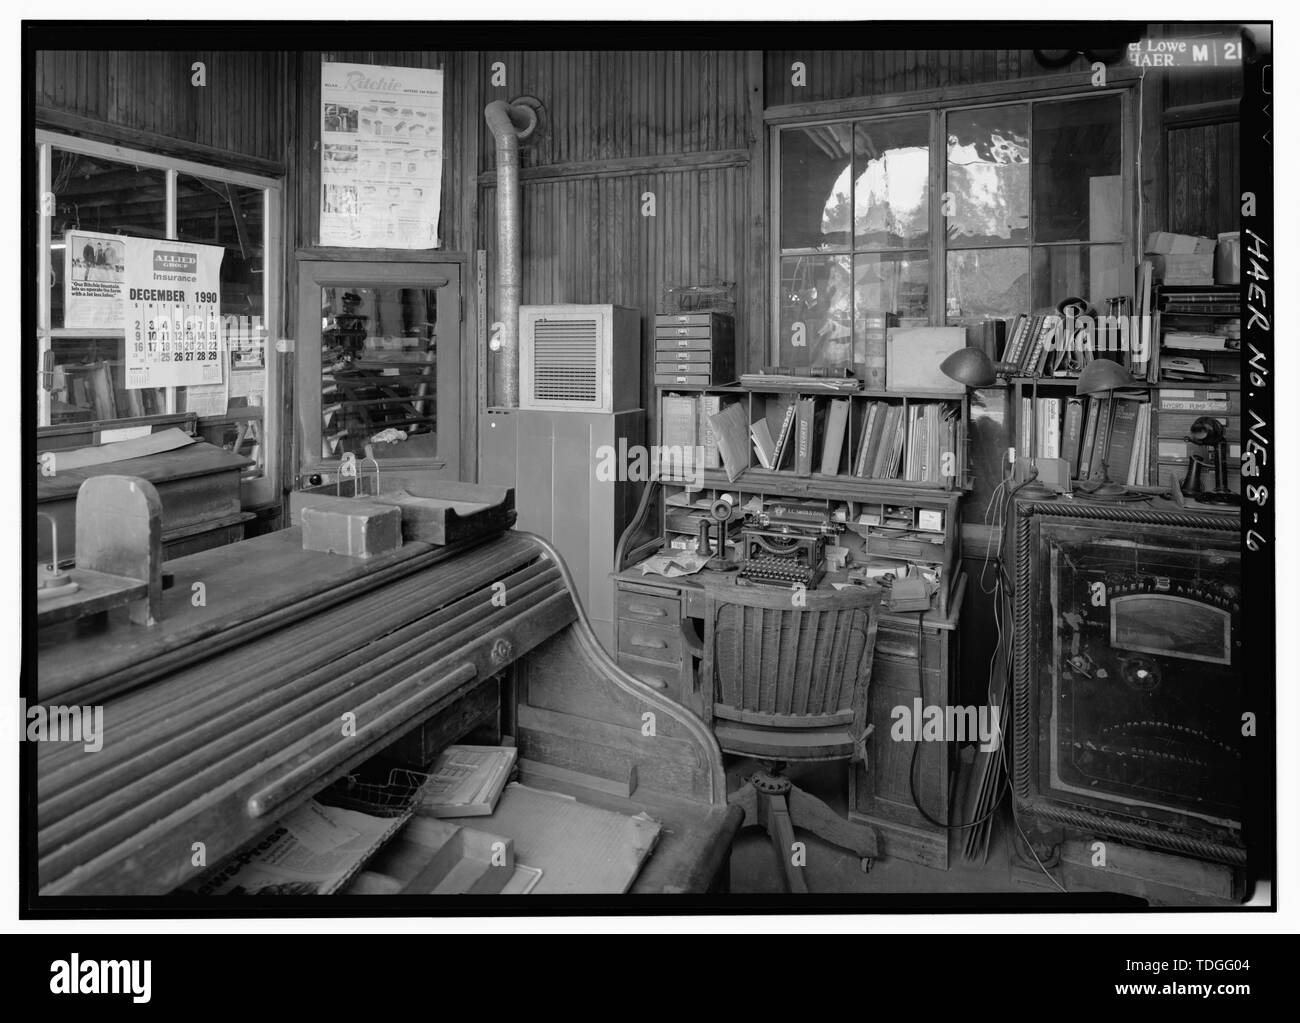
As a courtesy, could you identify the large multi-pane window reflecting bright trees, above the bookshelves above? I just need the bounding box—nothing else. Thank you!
[774,90,1134,369]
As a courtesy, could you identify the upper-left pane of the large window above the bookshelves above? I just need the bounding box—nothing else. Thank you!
[781,125,853,251]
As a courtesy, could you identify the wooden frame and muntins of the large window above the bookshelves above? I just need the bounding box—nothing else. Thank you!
[764,68,1143,363]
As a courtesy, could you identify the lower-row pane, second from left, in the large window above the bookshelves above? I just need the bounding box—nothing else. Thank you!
[853,252,930,390]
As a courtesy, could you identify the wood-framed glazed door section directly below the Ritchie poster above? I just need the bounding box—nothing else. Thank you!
[295,260,463,486]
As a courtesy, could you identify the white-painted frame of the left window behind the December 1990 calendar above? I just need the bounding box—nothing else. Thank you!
[35,129,283,508]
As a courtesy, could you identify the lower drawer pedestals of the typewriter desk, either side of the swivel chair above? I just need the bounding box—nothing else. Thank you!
[615,568,966,870]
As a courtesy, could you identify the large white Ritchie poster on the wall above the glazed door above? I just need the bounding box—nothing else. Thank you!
[320,64,442,248]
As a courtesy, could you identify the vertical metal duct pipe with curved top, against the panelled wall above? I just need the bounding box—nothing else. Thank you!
[484,100,537,408]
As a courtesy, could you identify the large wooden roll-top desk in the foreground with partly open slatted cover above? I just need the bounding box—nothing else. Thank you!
[31,528,741,896]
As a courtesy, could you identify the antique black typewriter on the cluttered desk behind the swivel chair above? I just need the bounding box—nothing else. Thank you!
[740,502,837,589]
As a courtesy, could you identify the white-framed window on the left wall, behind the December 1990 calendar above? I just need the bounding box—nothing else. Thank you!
[36,131,280,504]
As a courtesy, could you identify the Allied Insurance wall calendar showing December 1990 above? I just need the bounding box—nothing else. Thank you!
[124,238,225,389]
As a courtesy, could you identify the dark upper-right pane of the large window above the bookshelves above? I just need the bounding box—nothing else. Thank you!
[1034,95,1123,242]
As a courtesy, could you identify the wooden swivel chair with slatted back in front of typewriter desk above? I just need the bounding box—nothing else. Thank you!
[697,585,880,892]
